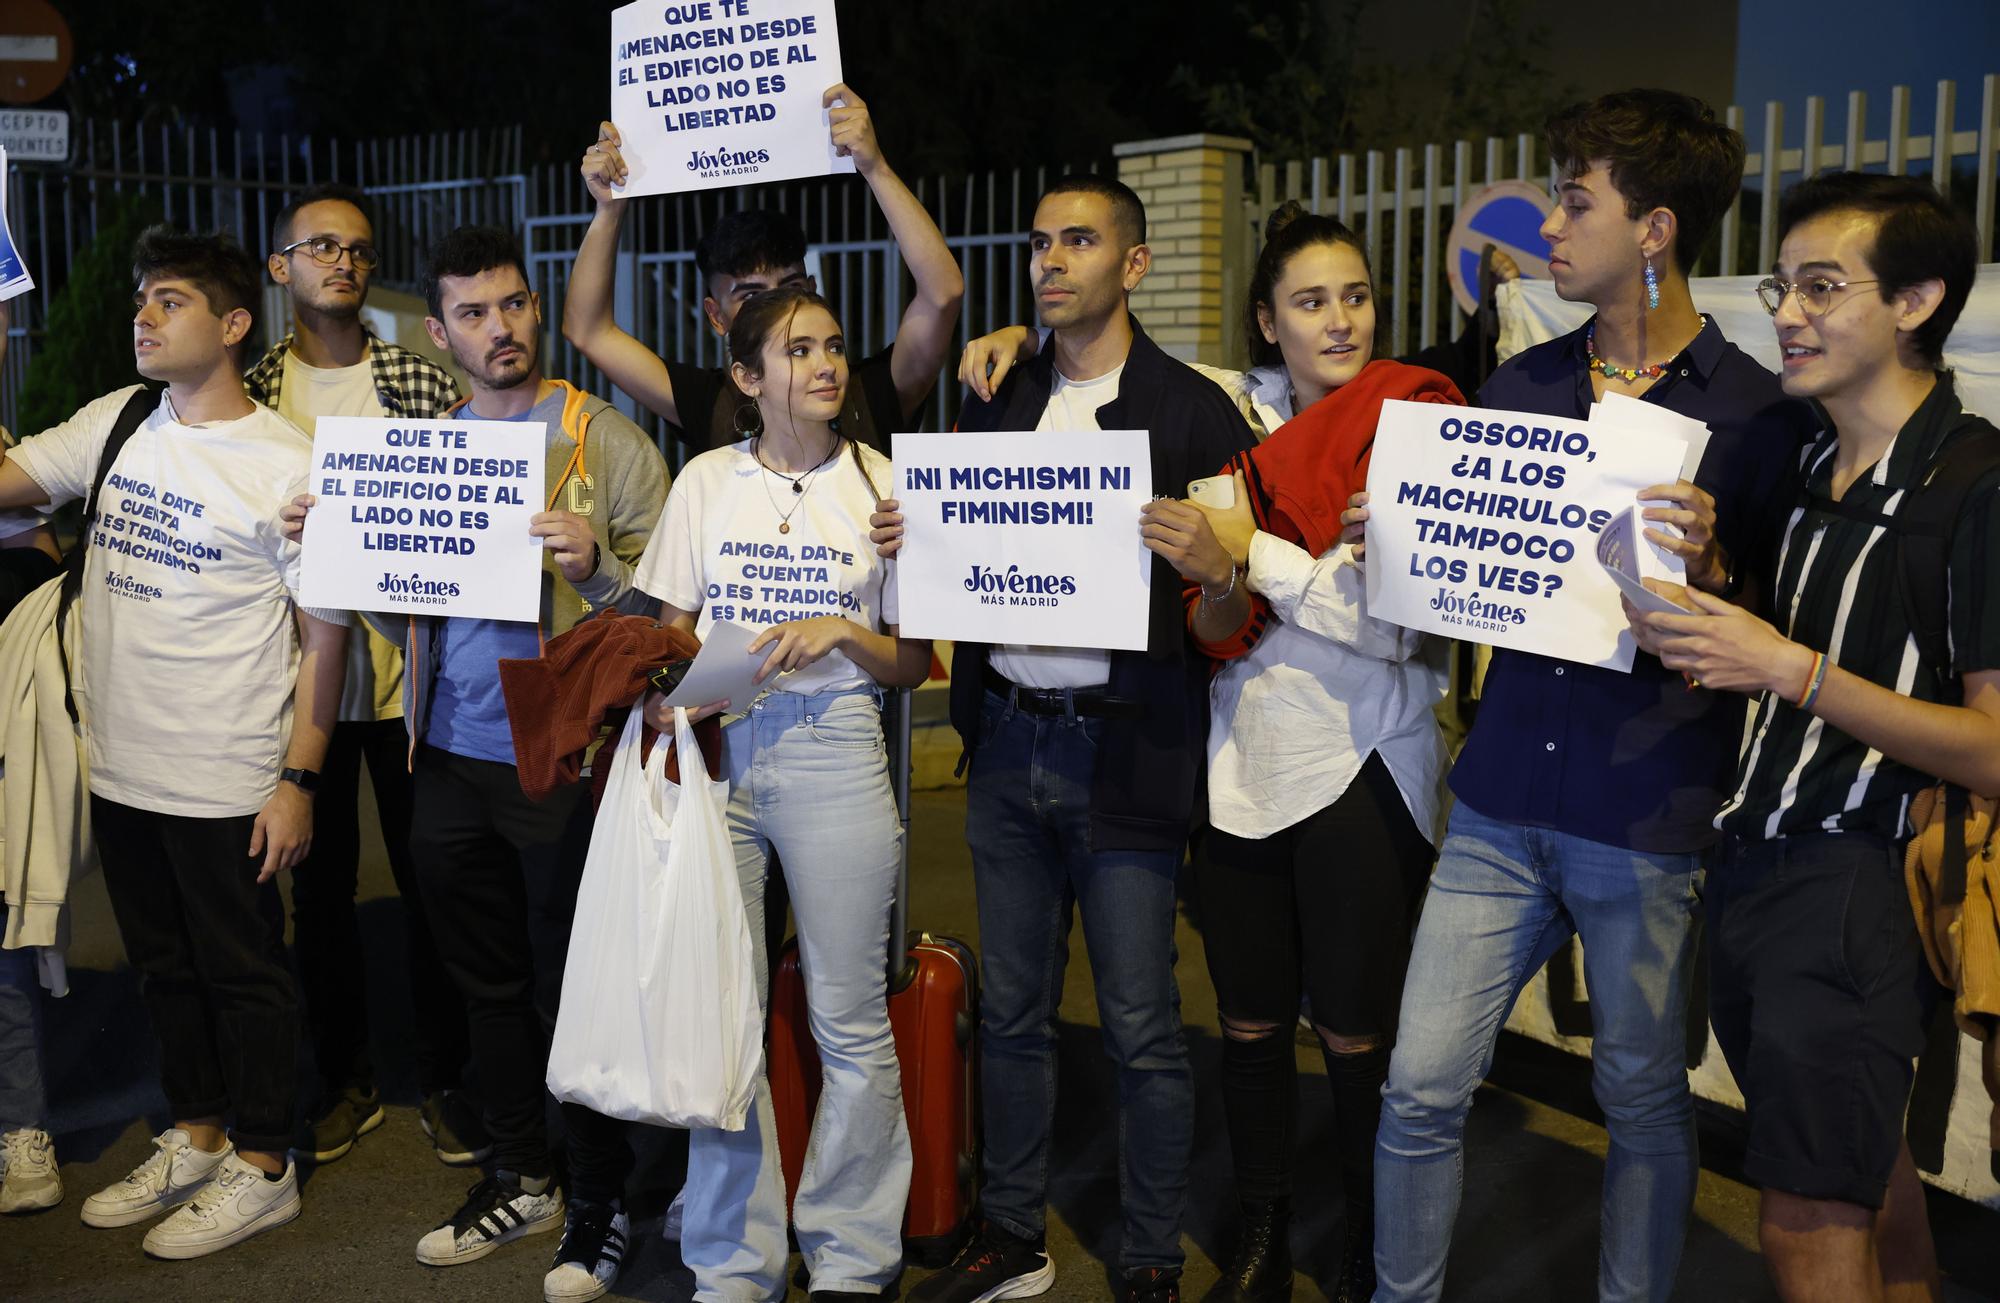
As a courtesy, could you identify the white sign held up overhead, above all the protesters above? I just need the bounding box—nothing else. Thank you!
[612,0,854,196]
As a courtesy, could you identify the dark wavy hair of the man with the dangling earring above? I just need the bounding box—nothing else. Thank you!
[1542,90,1744,274]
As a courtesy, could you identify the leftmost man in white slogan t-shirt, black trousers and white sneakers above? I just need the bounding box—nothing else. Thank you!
[0,226,348,1257]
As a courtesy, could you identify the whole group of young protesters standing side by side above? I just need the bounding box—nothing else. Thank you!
[0,86,2000,1303]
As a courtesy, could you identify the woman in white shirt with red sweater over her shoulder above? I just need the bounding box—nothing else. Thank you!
[1148,204,1464,1299]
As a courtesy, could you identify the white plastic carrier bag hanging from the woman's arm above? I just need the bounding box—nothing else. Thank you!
[548,707,764,1131]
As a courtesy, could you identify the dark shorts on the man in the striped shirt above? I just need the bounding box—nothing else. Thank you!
[1704,833,1934,1209]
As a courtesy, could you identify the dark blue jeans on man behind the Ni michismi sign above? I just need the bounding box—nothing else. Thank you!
[966,693,1194,1271]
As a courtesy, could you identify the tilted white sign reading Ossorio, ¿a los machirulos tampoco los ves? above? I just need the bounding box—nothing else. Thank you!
[1368,402,1686,671]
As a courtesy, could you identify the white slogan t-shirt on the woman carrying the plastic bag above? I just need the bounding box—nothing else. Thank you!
[634,440,900,695]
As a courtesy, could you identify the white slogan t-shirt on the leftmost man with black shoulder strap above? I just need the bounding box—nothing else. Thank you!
[8,386,312,819]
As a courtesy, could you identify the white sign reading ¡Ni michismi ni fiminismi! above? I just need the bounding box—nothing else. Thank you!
[894,430,1152,652]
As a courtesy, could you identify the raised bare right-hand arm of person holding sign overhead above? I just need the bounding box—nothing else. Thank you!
[824,82,966,416]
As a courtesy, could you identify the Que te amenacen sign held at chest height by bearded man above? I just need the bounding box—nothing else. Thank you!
[298,416,548,620]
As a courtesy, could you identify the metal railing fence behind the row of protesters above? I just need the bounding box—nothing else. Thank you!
[15,74,2000,438]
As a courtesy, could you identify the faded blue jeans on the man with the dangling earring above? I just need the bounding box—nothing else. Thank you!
[1376,803,1700,1303]
